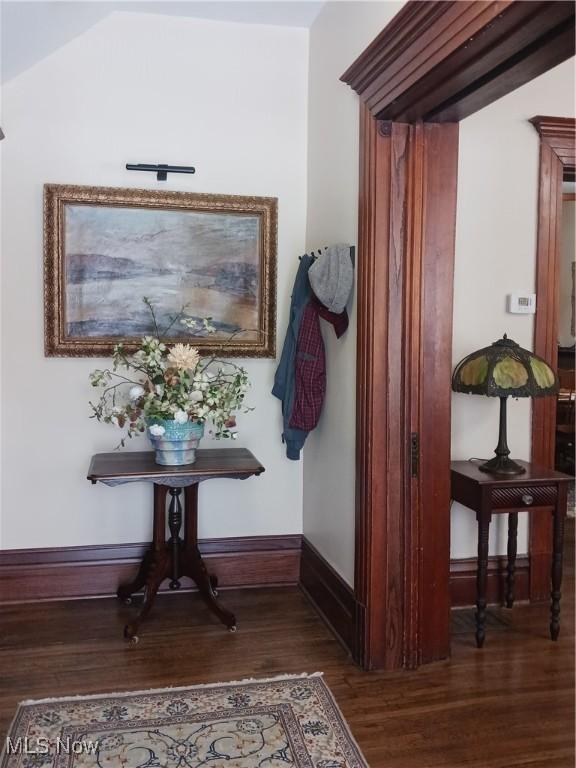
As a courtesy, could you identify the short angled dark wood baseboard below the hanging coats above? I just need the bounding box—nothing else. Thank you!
[300,538,358,658]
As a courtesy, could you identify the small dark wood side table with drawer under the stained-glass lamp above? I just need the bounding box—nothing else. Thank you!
[451,461,572,648]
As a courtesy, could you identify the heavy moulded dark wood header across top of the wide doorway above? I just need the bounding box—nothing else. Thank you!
[341,0,574,122]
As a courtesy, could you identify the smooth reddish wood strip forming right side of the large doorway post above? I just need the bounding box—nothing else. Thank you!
[413,123,458,663]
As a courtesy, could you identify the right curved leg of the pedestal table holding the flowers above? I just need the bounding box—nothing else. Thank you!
[182,483,236,632]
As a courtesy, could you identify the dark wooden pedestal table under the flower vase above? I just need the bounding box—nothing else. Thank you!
[88,448,264,643]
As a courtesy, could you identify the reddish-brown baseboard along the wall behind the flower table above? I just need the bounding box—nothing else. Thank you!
[0,535,302,604]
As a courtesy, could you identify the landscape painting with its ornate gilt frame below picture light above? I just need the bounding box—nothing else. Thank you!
[44,184,277,357]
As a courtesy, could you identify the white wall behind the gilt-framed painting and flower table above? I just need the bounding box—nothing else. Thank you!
[1,13,308,548]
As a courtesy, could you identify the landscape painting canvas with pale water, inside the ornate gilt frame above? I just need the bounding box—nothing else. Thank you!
[64,205,260,339]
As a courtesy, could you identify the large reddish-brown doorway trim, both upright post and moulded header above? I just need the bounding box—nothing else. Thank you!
[342,0,574,668]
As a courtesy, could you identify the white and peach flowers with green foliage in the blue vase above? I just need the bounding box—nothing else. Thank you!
[90,298,251,447]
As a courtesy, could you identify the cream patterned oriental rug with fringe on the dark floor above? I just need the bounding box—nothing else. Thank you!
[0,675,367,768]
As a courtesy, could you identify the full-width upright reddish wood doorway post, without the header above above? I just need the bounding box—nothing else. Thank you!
[356,106,458,668]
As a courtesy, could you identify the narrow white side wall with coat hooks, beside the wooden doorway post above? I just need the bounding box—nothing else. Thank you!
[304,2,402,584]
